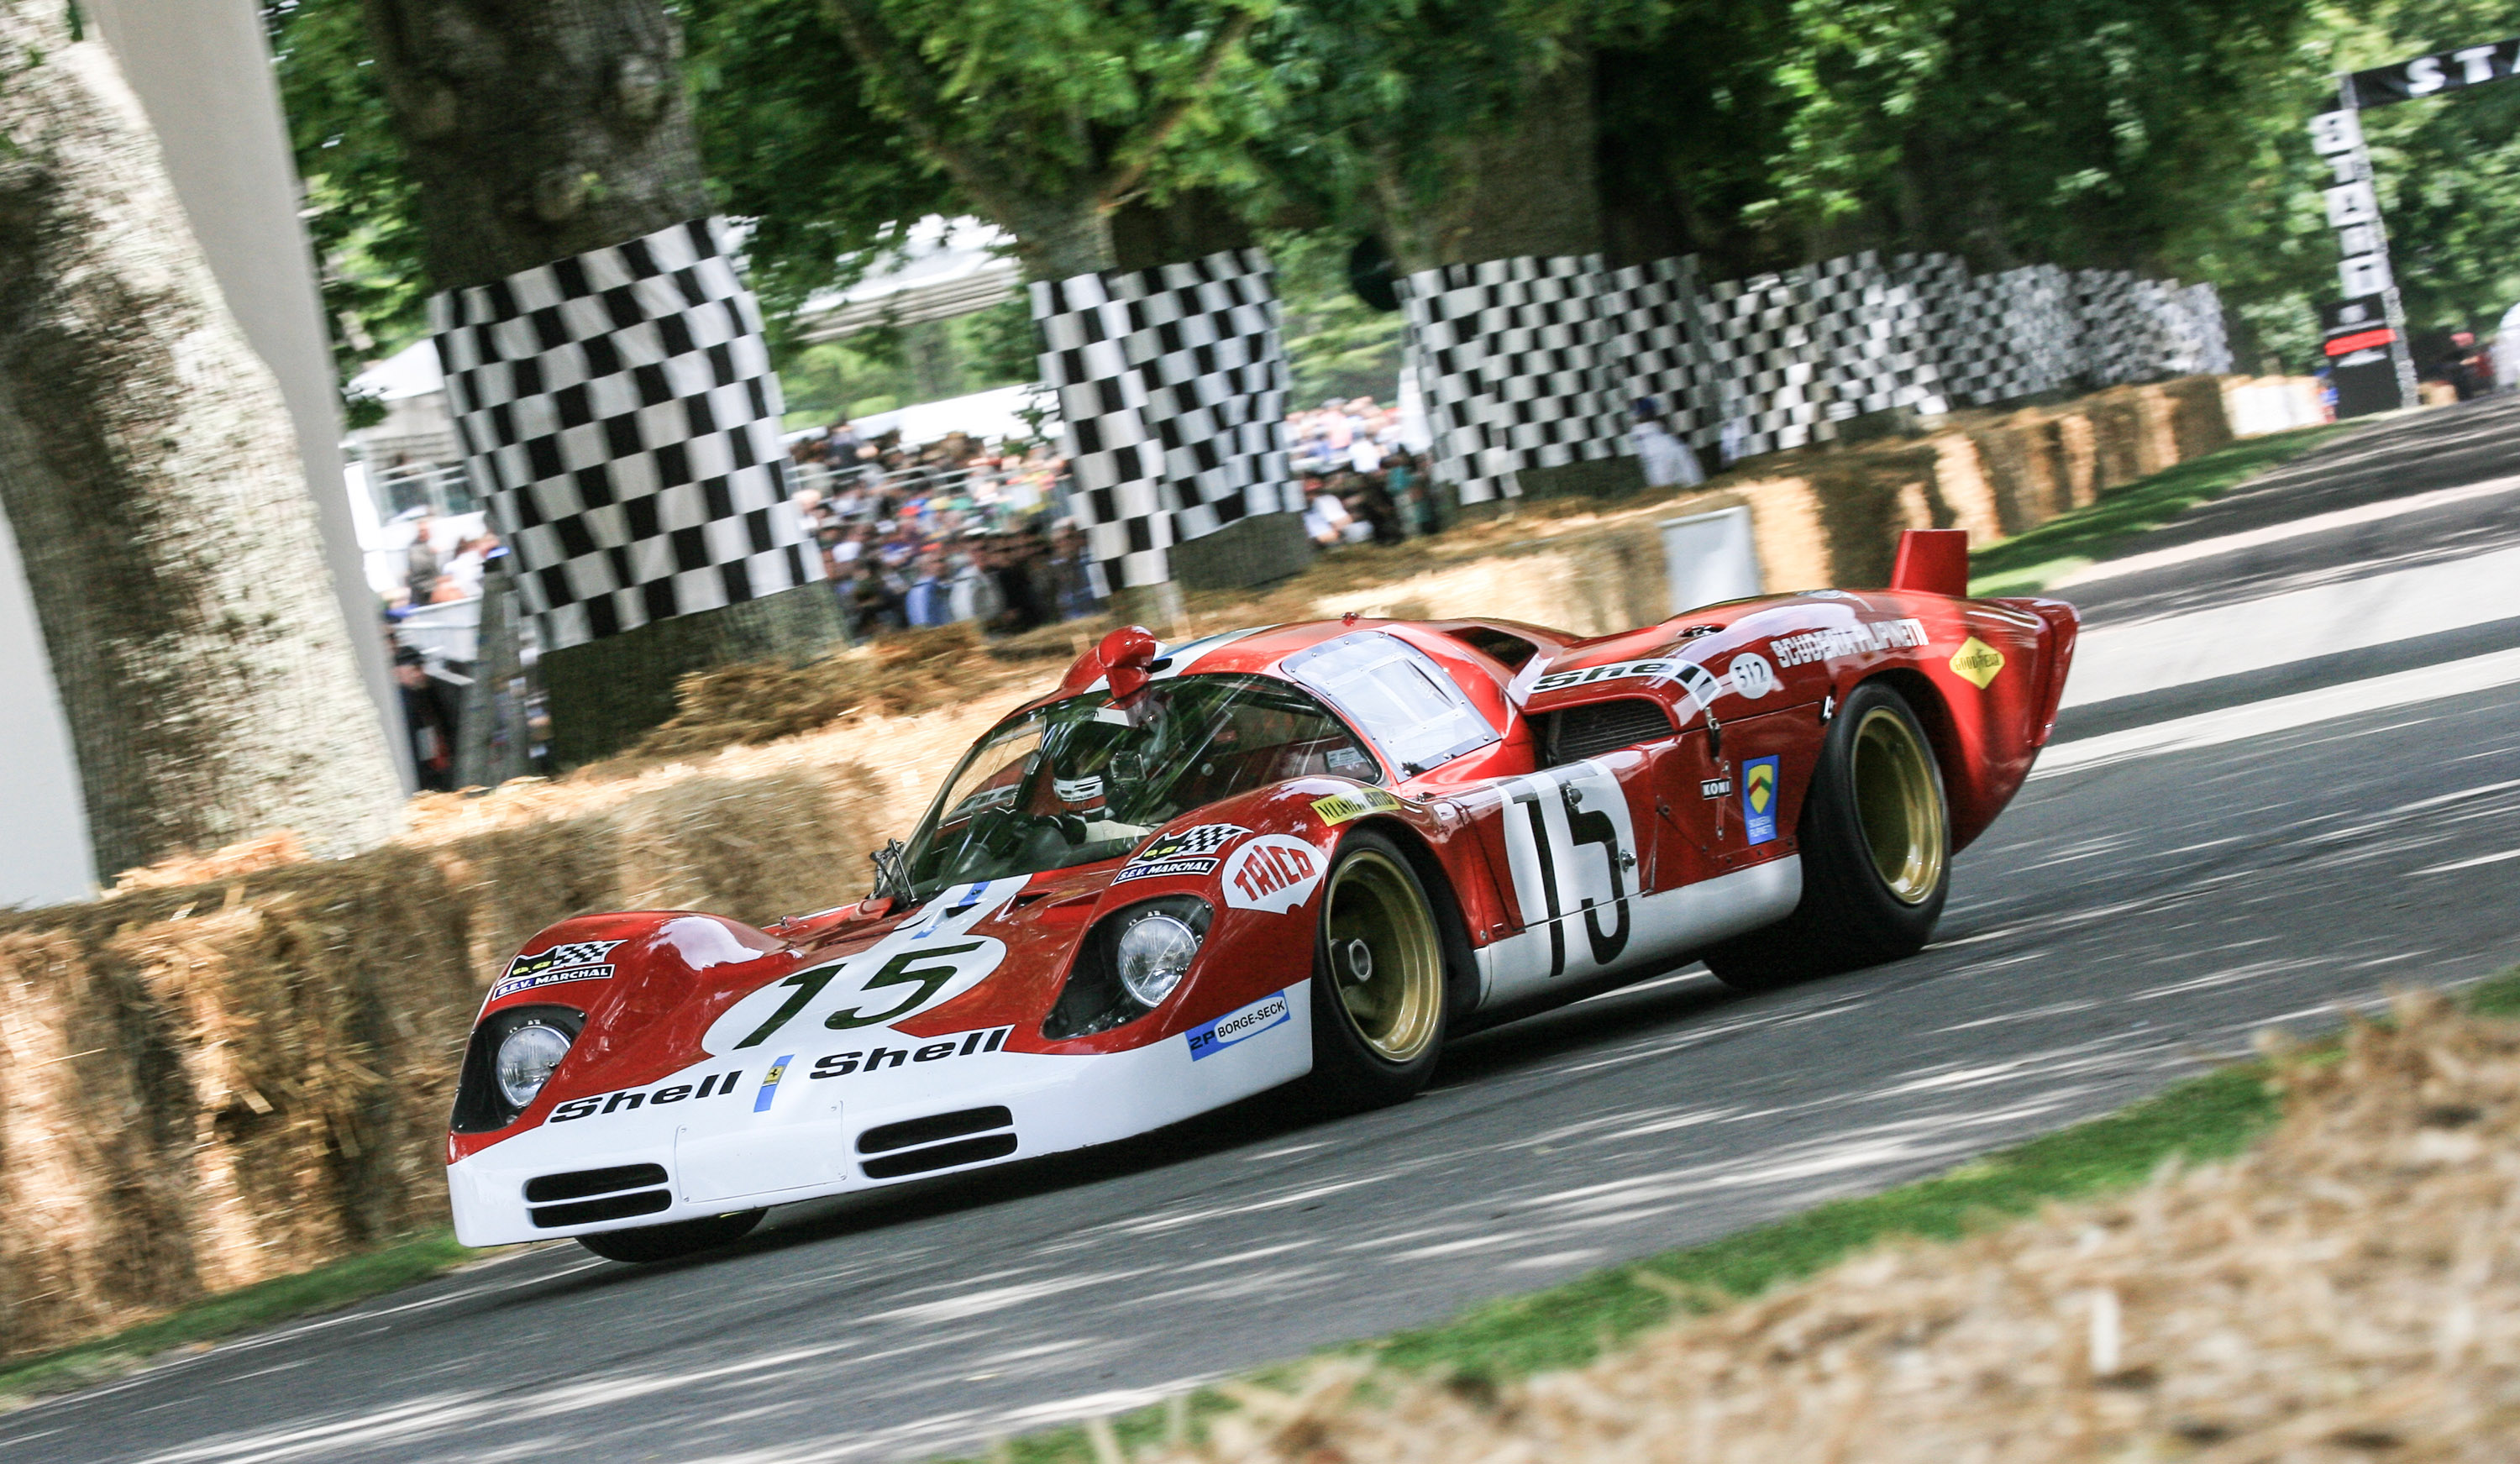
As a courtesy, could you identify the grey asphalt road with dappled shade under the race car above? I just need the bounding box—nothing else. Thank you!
[19,403,2520,1464]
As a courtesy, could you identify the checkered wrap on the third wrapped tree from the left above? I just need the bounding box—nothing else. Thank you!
[1401,254,1628,504]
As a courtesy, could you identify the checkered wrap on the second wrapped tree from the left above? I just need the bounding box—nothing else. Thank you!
[1033,249,1300,585]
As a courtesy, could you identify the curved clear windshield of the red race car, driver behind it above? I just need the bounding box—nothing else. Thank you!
[905,675,1381,900]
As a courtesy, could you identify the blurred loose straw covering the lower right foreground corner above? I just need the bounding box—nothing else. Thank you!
[1157,995,2520,1464]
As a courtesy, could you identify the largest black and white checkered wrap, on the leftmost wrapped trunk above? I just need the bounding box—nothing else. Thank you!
[428,219,822,650]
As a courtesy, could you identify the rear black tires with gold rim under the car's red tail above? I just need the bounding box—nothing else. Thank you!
[1701,680,1950,990]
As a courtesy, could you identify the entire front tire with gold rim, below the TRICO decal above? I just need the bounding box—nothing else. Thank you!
[1308,829,1452,1114]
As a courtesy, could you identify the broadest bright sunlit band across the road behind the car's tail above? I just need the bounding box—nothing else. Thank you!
[2064,549,2520,706]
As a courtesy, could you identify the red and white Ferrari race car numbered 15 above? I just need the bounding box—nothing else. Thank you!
[446,532,2076,1260]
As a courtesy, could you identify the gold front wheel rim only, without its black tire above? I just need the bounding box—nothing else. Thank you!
[1320,849,1444,1063]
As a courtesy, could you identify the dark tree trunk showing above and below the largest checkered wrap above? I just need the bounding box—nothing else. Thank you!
[365,0,842,761]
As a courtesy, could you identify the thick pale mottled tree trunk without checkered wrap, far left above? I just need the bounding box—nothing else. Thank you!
[0,5,401,874]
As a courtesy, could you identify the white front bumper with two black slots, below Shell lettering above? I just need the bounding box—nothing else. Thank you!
[446,985,1313,1245]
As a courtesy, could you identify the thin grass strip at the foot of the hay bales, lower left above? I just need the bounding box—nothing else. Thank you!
[0,1230,489,1409]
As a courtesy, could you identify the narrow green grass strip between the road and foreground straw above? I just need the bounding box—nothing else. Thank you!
[953,970,2520,1464]
